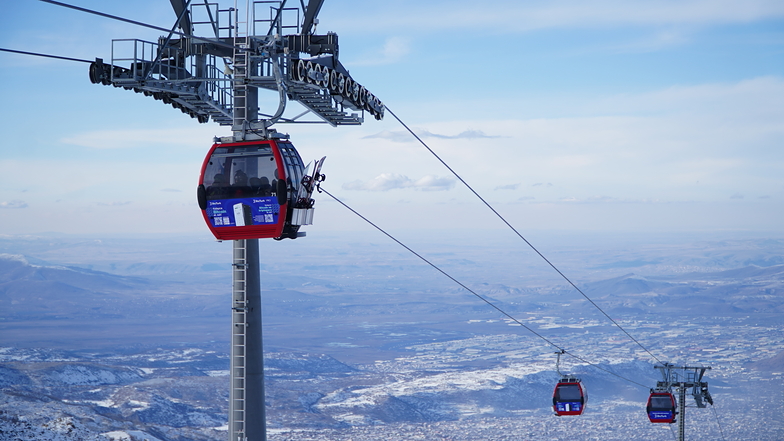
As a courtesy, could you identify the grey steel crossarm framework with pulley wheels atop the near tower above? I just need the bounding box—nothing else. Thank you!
[90,0,384,131]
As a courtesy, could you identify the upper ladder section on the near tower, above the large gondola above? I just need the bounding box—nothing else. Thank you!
[232,0,251,130]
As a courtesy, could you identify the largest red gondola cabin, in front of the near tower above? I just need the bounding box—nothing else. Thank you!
[198,139,304,240]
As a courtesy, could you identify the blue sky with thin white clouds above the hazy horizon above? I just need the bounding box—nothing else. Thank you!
[0,0,784,236]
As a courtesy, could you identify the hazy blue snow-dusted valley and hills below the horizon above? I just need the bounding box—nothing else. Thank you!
[0,232,784,441]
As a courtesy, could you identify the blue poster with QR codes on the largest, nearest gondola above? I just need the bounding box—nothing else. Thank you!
[207,197,280,227]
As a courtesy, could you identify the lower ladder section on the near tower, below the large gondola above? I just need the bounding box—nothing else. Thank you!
[229,240,248,441]
